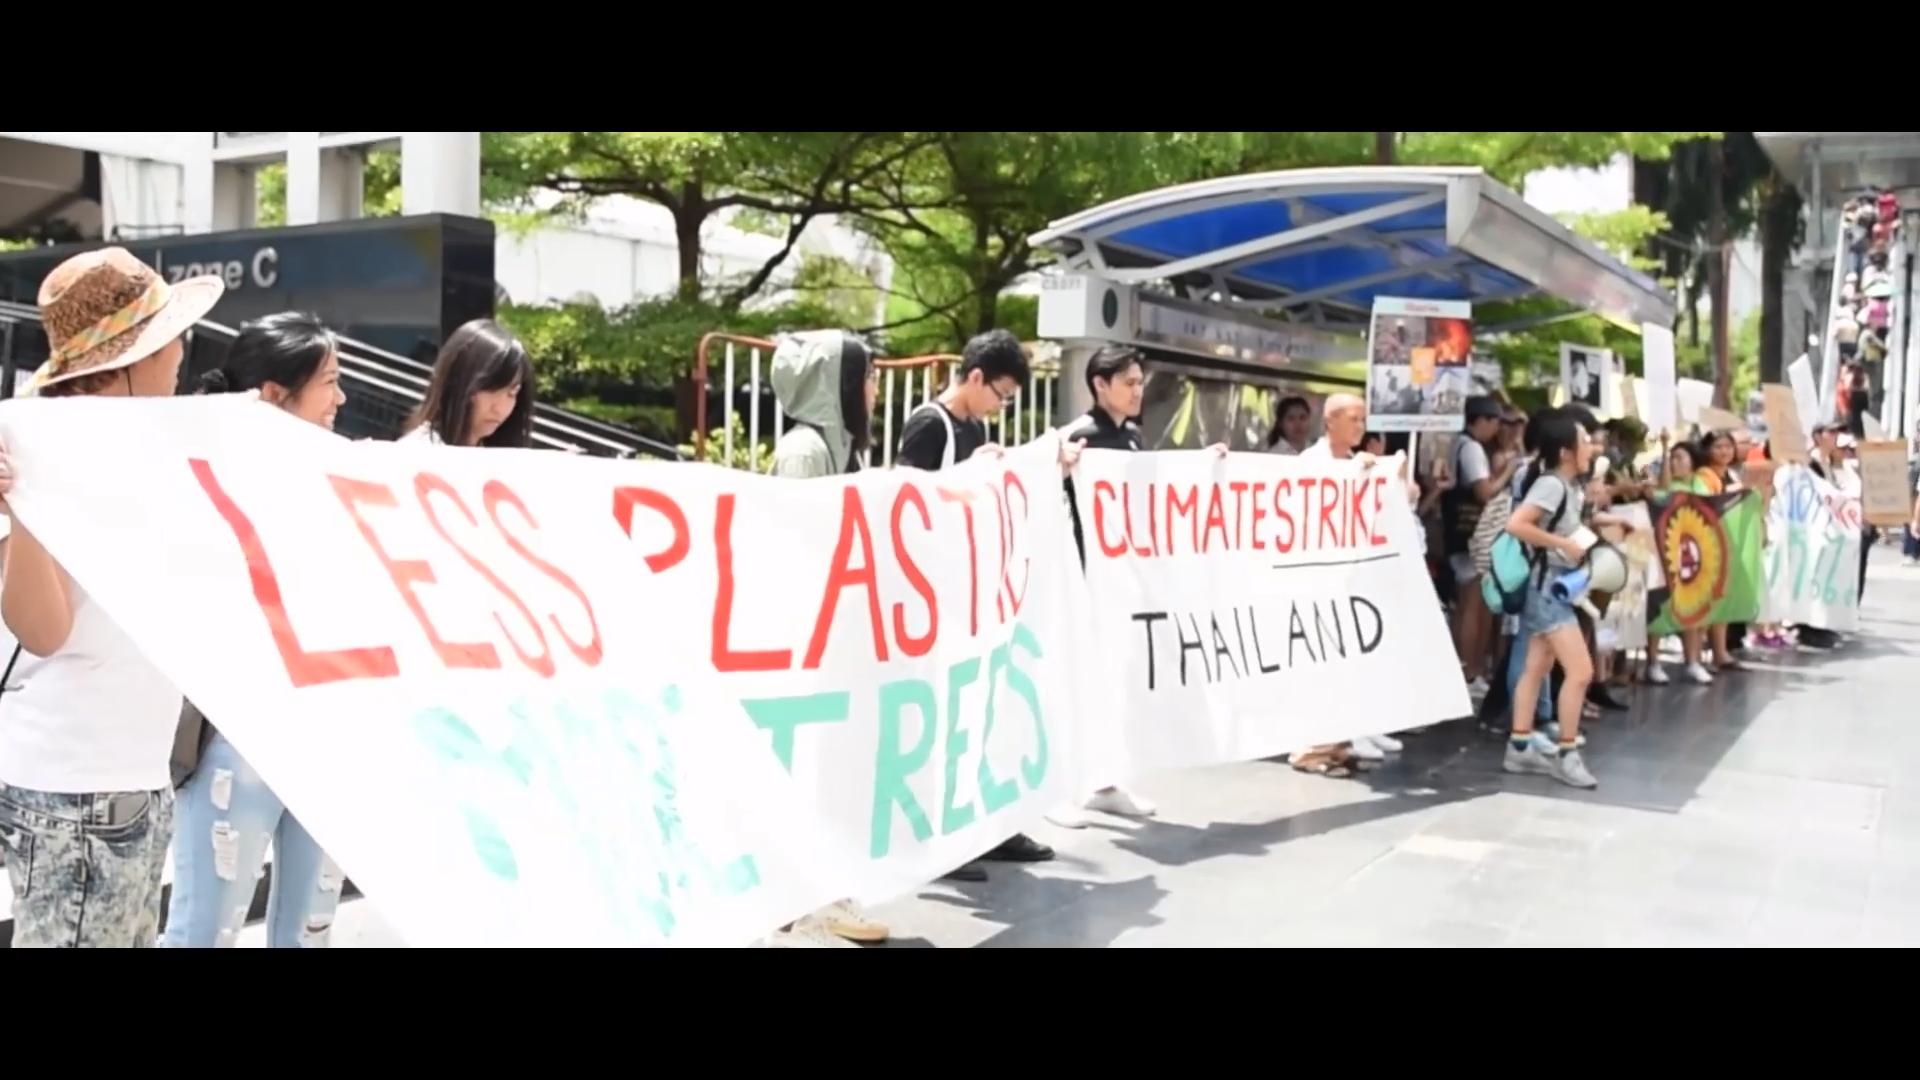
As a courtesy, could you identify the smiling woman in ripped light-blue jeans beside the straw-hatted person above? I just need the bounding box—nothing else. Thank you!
[165,311,348,949]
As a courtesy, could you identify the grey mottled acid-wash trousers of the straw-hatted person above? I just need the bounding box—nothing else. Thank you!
[0,784,173,949]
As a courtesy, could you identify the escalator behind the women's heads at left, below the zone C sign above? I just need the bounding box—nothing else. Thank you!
[0,300,682,461]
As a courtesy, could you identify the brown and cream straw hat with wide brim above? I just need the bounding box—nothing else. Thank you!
[33,248,225,390]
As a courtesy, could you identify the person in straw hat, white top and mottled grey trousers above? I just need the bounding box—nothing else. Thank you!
[0,248,221,947]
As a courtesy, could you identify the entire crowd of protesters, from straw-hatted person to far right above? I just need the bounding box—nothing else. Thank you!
[0,239,1920,947]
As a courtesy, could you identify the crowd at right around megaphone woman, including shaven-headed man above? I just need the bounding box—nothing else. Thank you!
[1269,378,1920,788]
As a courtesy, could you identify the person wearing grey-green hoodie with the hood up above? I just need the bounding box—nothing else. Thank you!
[774,331,889,945]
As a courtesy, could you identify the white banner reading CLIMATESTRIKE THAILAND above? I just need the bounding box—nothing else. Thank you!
[1073,450,1471,776]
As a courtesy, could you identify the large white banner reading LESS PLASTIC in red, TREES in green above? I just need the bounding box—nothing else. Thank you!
[0,398,1077,945]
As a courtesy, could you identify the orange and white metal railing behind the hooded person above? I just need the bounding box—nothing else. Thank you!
[693,332,1060,467]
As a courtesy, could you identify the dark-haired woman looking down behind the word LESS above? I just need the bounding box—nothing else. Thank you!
[399,319,534,446]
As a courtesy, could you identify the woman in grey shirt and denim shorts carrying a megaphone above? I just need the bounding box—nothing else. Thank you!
[1501,409,1628,788]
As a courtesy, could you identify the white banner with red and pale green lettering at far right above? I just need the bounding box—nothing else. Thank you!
[1761,465,1860,632]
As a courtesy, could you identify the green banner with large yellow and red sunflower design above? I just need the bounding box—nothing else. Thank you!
[1647,490,1766,634]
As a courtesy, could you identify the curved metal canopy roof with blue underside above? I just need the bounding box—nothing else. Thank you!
[1033,167,1674,329]
